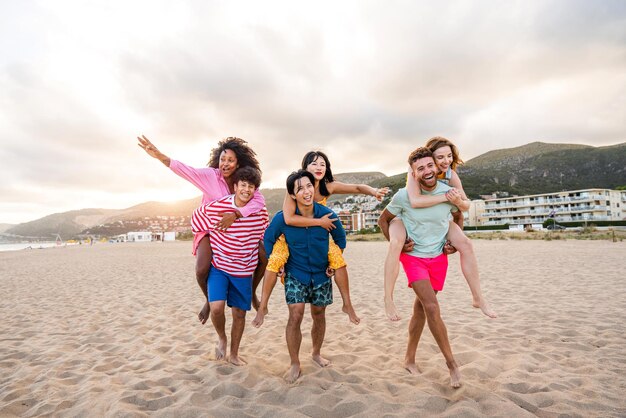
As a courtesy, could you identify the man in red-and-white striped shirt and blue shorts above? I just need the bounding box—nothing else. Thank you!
[191,167,269,366]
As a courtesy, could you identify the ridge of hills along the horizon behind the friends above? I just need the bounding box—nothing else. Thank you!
[0,142,626,237]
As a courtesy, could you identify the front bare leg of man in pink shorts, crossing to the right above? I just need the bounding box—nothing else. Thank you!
[412,280,461,388]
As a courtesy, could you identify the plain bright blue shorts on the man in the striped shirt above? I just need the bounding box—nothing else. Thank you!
[207,266,252,311]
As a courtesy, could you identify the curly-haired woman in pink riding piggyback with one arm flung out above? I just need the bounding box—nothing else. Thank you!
[137,135,267,324]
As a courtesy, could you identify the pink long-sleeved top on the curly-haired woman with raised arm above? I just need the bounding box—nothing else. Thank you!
[170,159,265,255]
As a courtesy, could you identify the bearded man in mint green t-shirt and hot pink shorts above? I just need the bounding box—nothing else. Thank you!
[378,147,463,388]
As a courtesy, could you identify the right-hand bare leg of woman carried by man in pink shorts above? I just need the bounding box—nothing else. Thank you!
[448,222,498,318]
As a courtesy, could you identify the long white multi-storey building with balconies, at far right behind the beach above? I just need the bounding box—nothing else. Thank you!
[478,189,626,229]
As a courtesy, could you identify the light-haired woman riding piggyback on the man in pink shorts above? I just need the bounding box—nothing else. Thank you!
[385,136,497,321]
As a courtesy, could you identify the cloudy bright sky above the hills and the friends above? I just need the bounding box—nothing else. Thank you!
[0,0,626,223]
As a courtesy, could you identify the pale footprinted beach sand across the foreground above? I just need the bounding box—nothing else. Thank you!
[0,240,626,417]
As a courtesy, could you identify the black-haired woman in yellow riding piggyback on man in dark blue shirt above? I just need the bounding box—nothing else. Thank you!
[267,151,389,324]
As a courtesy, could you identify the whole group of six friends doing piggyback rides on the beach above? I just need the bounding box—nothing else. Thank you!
[137,136,496,387]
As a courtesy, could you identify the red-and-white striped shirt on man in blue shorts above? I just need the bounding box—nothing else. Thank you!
[191,195,269,277]
